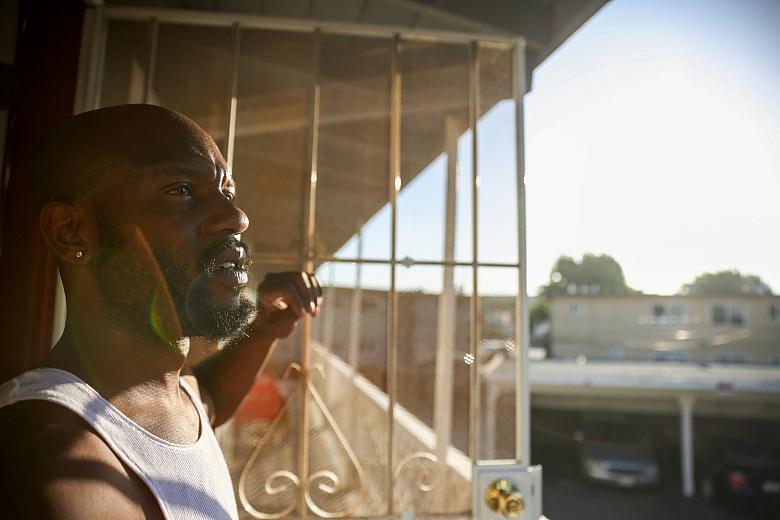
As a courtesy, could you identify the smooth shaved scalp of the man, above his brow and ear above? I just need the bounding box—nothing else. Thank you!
[34,104,222,207]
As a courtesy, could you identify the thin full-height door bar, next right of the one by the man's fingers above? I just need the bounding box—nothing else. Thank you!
[385,34,401,516]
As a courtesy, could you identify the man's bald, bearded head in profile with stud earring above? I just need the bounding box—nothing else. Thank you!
[35,105,254,350]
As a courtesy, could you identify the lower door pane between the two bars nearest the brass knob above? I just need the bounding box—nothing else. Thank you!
[393,266,472,513]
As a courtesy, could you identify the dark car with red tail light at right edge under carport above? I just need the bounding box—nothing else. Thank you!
[701,446,780,506]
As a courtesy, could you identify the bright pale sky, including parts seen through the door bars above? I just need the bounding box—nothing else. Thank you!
[327,0,780,295]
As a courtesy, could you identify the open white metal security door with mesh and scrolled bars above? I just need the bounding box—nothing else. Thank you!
[77,7,529,518]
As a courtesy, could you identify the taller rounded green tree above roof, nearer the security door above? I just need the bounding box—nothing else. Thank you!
[542,253,636,296]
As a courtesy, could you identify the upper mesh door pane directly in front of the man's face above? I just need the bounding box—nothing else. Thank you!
[233,30,312,258]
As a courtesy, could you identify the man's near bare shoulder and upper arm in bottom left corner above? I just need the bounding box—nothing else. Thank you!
[0,401,161,519]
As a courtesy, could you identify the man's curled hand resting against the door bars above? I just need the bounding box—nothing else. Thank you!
[255,271,322,338]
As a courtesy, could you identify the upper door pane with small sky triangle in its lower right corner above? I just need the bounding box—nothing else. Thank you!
[316,35,391,260]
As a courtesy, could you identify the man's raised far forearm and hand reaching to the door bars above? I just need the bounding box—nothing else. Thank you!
[193,272,322,426]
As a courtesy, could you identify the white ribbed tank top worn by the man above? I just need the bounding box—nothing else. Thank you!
[0,368,238,520]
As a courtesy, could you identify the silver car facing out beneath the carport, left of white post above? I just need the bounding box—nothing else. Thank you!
[575,416,659,487]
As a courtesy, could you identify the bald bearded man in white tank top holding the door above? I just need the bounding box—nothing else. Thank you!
[0,105,322,519]
